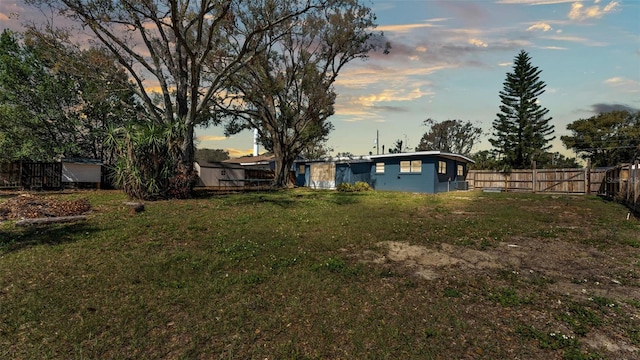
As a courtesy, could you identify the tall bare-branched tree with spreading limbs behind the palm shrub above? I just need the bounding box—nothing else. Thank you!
[28,0,329,197]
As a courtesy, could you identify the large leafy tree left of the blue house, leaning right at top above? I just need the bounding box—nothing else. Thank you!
[218,0,382,187]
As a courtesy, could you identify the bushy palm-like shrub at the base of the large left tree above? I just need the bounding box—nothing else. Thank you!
[105,122,196,200]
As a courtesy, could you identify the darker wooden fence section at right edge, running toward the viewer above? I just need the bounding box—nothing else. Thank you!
[601,161,640,213]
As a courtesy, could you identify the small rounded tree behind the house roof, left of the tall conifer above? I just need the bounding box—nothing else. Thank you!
[416,119,482,155]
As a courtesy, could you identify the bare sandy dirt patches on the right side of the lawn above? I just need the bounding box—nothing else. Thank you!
[362,238,640,356]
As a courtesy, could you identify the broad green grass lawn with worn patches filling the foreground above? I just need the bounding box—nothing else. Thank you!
[0,189,640,359]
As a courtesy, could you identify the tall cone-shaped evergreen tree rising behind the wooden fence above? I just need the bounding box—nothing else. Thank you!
[489,50,555,168]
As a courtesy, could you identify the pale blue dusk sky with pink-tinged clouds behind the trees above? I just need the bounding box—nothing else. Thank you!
[0,0,640,157]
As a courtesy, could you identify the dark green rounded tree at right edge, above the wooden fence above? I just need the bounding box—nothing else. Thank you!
[560,110,640,166]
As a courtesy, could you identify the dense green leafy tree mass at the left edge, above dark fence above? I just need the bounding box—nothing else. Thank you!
[0,30,137,162]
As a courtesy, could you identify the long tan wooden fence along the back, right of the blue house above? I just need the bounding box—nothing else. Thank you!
[467,168,606,194]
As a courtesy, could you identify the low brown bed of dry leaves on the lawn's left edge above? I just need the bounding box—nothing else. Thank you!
[0,194,91,221]
